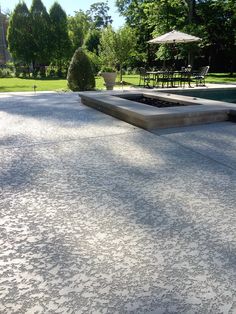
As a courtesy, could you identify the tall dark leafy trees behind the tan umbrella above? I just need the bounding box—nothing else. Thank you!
[116,0,236,70]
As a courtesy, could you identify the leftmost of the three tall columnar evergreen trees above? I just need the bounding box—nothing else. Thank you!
[7,2,32,65]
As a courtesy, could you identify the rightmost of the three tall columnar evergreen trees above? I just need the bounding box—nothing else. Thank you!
[49,2,71,72]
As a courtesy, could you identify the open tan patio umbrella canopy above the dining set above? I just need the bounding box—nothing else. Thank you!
[148,30,201,44]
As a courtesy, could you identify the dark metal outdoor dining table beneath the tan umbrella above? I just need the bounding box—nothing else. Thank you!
[146,70,191,87]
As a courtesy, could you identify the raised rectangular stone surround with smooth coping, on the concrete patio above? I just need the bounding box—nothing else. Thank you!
[79,91,235,130]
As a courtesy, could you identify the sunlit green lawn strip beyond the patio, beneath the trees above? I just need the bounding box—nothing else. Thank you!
[0,73,236,92]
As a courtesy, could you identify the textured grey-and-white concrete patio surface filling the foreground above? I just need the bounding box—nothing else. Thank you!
[0,93,236,314]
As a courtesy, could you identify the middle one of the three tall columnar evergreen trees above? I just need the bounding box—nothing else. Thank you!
[30,0,52,67]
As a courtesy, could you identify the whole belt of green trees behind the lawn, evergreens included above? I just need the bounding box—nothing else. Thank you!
[8,0,236,79]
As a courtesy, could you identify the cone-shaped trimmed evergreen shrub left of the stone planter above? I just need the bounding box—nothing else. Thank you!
[67,48,95,92]
